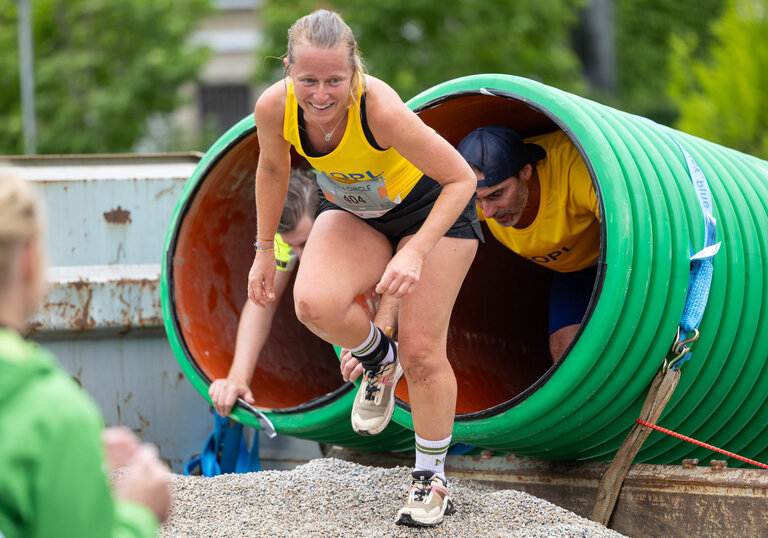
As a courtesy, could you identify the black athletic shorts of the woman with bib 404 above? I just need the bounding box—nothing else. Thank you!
[315,176,485,251]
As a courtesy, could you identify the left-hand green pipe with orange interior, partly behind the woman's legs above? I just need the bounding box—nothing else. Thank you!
[161,116,413,451]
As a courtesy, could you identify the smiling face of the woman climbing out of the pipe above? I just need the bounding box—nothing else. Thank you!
[289,43,354,127]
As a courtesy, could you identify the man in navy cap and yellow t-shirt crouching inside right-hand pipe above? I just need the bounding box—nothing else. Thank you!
[458,125,600,360]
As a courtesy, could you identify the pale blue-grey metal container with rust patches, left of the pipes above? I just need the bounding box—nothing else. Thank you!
[10,153,321,472]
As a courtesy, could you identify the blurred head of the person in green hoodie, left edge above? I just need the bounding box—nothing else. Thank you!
[0,164,45,330]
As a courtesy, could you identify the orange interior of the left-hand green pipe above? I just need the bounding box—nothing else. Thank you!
[173,131,343,409]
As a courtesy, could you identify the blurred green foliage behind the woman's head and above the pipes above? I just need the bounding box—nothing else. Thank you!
[257,0,585,99]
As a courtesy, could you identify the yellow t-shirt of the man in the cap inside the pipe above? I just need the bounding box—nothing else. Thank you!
[478,131,600,273]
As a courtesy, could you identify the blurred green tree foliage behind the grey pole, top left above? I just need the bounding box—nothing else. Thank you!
[0,0,210,154]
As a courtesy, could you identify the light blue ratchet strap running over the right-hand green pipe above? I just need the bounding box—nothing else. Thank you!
[665,129,720,370]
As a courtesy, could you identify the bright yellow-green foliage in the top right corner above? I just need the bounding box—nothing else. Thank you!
[670,0,768,159]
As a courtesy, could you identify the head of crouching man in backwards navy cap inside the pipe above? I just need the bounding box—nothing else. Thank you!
[457,125,547,226]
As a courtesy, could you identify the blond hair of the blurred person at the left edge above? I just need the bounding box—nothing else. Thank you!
[0,163,40,294]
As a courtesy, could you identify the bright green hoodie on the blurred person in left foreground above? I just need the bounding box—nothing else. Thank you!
[0,330,158,538]
